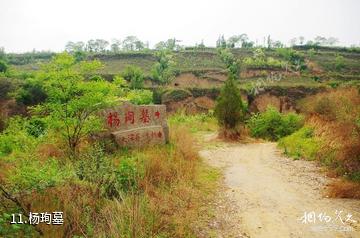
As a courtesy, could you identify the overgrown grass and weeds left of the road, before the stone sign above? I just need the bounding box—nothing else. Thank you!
[0,112,220,237]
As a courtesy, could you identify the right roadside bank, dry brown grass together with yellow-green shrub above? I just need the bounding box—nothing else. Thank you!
[279,87,360,198]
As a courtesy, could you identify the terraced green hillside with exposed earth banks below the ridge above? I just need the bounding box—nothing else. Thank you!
[8,45,360,113]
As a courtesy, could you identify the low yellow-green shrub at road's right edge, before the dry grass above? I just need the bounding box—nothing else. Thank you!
[278,127,320,160]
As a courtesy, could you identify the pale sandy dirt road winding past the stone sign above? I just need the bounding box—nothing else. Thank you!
[200,143,360,238]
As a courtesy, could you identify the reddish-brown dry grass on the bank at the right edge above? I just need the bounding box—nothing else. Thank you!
[301,88,360,198]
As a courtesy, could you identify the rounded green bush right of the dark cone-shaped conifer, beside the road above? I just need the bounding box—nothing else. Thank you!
[247,107,304,141]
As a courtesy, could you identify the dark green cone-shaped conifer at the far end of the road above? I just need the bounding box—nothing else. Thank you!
[214,75,245,130]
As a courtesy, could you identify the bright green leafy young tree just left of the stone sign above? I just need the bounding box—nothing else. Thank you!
[34,53,116,158]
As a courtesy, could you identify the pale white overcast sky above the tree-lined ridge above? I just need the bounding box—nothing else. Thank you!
[0,0,360,52]
